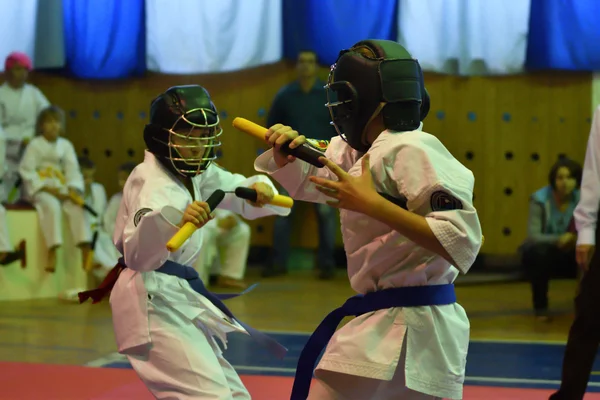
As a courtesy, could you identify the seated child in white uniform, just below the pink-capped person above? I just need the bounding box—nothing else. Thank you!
[19,106,92,272]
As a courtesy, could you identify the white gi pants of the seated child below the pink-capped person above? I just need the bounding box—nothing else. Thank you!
[32,191,92,249]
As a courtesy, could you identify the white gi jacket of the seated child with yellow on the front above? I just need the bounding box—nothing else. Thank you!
[19,135,84,199]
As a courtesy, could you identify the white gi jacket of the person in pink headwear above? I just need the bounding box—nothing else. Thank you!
[0,82,50,141]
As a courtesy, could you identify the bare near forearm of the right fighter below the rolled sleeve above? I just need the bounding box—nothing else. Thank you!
[368,197,456,265]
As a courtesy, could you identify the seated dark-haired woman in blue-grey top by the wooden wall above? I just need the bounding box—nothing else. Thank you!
[520,158,582,321]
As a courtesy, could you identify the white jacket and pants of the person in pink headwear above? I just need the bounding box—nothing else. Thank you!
[0,82,50,203]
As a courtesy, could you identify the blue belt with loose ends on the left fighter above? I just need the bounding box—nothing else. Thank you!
[131,259,287,358]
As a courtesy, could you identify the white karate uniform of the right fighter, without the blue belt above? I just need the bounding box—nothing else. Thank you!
[255,129,481,400]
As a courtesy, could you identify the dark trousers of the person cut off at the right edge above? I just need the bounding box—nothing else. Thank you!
[550,245,600,400]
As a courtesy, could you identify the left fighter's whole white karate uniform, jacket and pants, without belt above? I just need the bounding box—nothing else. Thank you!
[110,151,289,399]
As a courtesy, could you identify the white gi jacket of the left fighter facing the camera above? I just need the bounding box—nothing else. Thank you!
[110,151,290,353]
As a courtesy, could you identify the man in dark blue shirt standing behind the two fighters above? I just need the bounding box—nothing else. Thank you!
[263,50,338,279]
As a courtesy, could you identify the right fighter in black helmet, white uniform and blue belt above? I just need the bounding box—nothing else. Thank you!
[255,40,482,400]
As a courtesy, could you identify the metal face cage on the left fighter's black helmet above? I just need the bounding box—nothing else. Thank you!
[165,108,223,176]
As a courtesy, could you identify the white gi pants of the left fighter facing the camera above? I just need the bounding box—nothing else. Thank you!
[126,296,251,400]
